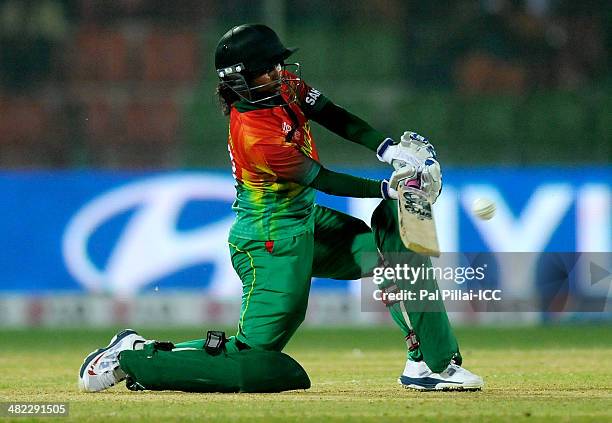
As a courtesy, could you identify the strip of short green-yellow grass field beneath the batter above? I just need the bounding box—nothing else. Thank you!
[0,325,612,422]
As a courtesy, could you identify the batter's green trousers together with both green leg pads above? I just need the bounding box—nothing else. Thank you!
[120,200,461,392]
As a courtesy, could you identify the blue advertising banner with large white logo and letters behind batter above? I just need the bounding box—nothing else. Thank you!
[0,167,612,296]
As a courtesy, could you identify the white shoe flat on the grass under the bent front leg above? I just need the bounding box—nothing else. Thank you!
[397,360,484,391]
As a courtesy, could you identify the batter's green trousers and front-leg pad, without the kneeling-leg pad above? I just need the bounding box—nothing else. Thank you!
[222,200,460,372]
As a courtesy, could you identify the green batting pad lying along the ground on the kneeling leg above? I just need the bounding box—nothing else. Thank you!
[119,345,310,392]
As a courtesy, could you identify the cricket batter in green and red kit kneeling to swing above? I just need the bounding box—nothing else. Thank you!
[79,24,484,392]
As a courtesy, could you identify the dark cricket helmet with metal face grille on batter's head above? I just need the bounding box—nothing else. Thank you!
[215,24,299,103]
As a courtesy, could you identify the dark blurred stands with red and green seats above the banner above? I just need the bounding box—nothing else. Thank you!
[0,0,612,169]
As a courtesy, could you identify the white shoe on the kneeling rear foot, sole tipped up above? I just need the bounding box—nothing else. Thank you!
[79,329,146,392]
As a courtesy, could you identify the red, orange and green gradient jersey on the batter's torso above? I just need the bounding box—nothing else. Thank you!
[228,71,327,240]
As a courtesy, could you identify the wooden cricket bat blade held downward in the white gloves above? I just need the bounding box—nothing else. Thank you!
[393,163,440,257]
